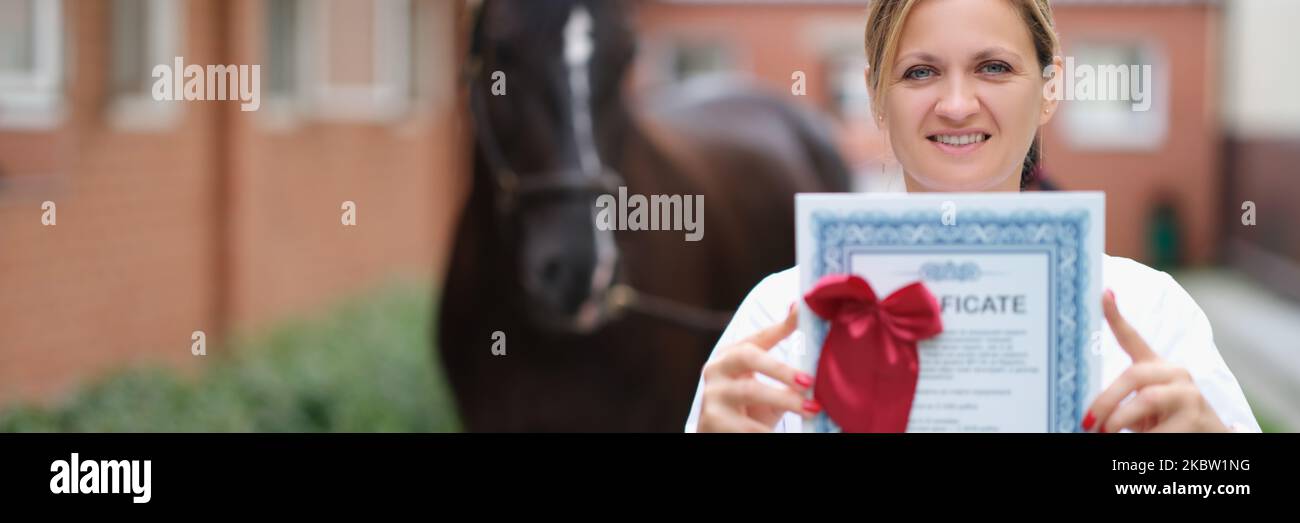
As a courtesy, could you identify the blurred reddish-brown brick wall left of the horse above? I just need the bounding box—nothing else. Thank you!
[0,0,460,403]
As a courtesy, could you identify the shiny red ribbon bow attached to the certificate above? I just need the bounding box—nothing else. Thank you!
[803,275,944,432]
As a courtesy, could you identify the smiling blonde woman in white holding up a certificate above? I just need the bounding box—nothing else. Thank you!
[686,0,1260,432]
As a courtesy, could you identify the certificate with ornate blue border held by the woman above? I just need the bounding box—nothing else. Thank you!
[796,193,1105,432]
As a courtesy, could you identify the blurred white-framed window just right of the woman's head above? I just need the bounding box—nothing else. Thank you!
[1061,42,1169,151]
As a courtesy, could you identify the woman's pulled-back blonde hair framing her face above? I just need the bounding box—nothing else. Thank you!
[863,0,1061,187]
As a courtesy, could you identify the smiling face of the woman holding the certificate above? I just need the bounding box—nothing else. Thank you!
[880,0,1060,191]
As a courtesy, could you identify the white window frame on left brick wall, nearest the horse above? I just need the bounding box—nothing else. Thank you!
[303,0,412,122]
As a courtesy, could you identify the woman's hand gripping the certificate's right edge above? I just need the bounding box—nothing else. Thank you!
[1083,290,1229,432]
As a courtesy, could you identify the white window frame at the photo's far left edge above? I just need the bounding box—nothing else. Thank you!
[0,0,65,130]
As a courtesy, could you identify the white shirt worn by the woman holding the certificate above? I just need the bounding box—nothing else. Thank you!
[686,256,1260,432]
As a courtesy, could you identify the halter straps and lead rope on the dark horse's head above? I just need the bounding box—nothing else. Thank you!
[465,7,732,332]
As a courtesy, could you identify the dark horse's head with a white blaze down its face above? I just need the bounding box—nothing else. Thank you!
[469,0,636,333]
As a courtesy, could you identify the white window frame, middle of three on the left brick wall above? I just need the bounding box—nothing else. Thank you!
[108,0,185,133]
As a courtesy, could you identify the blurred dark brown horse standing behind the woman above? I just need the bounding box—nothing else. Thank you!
[437,0,849,431]
